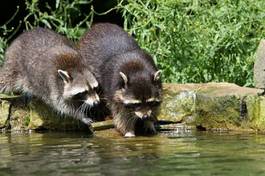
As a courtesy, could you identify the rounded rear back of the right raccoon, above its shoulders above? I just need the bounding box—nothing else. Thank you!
[78,23,139,75]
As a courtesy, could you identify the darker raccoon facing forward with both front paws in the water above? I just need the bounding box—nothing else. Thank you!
[78,23,162,137]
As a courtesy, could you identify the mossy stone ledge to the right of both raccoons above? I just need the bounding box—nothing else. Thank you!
[159,83,265,131]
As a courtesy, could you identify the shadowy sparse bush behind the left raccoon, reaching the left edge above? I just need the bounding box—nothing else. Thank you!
[0,0,94,64]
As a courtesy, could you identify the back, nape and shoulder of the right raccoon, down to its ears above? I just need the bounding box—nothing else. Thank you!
[78,23,157,96]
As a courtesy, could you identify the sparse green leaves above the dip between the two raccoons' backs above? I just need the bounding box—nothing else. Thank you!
[24,0,94,39]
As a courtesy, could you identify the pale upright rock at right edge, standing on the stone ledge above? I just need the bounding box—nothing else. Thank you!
[254,40,265,89]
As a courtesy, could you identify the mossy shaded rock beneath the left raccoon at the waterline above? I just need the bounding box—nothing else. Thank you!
[0,97,88,131]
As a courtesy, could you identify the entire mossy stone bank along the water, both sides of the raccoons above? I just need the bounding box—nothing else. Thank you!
[0,83,265,132]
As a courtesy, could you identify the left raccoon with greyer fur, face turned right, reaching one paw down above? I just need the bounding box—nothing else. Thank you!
[0,27,99,126]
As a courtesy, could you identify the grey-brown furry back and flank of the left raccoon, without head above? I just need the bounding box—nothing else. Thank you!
[1,28,77,100]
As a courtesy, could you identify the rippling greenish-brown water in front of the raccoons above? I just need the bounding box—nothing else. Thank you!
[0,132,265,176]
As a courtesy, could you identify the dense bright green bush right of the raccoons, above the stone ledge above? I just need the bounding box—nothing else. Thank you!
[121,0,265,86]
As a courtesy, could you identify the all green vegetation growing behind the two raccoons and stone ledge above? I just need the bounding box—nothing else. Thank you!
[0,0,265,86]
